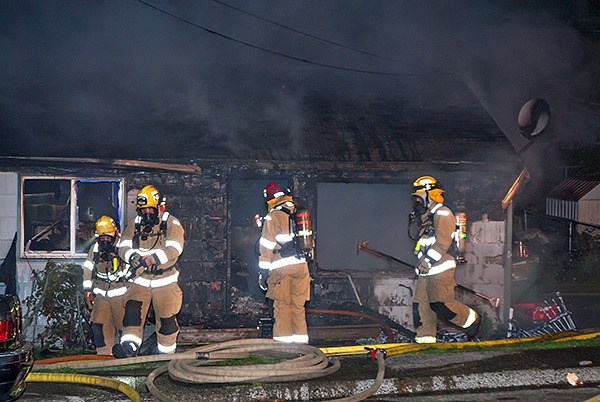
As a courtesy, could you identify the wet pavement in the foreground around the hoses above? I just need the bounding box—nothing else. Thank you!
[22,333,600,402]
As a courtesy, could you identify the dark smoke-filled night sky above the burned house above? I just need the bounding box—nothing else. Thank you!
[0,0,600,171]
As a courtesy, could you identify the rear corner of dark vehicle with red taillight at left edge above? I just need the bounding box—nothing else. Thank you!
[0,295,33,402]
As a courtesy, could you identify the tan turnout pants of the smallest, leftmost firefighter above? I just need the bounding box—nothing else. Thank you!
[91,295,125,356]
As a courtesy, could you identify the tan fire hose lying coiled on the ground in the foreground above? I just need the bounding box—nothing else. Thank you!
[34,338,385,402]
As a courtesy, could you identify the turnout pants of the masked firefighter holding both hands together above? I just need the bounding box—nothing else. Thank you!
[122,282,183,353]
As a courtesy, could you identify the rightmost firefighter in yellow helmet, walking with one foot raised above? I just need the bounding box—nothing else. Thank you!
[412,176,481,343]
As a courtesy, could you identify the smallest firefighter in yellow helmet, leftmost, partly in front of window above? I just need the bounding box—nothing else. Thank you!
[83,215,127,356]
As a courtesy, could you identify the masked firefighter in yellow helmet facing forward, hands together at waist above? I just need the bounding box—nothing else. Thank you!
[113,185,184,358]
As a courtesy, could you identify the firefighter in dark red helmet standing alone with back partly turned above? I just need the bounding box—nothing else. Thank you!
[258,183,310,344]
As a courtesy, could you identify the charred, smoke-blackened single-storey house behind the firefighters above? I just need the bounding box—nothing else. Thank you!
[0,81,521,336]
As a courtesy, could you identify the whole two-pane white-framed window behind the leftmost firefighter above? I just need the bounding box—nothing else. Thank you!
[20,177,124,257]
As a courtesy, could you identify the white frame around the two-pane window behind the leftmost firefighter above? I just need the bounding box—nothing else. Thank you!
[19,175,127,259]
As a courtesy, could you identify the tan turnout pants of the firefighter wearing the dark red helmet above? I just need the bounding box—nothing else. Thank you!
[266,263,310,343]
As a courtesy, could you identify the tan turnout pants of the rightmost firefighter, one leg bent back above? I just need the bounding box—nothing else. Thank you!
[413,269,471,338]
